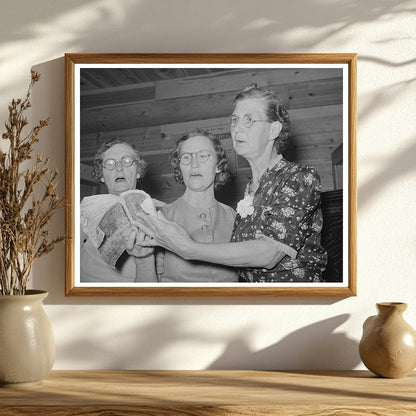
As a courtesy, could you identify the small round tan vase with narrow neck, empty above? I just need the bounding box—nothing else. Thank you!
[359,303,416,378]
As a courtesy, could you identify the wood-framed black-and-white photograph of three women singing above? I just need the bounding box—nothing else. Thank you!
[65,54,356,297]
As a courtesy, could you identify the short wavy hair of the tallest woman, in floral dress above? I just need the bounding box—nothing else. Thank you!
[234,84,290,153]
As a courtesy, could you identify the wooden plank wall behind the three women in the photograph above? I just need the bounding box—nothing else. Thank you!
[80,68,342,207]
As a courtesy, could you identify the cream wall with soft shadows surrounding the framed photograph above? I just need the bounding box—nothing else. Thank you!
[0,0,416,369]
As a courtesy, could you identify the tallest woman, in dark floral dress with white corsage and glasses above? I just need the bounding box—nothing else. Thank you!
[141,85,327,283]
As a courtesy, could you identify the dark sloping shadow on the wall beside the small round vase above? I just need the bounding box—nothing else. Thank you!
[208,314,360,370]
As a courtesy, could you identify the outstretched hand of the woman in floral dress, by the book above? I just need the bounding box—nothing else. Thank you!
[137,211,195,259]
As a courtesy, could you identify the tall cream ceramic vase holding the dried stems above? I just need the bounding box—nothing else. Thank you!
[0,290,55,387]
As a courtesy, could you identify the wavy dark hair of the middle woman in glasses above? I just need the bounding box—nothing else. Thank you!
[170,129,230,189]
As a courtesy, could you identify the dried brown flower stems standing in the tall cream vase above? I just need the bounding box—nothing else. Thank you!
[0,71,66,295]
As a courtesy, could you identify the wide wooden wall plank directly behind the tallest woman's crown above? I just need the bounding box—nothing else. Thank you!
[81,78,342,134]
